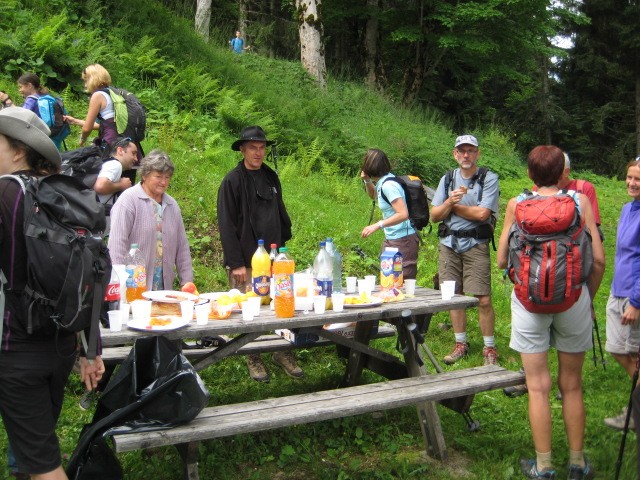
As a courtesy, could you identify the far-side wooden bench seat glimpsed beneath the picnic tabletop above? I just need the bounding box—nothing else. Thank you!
[102,325,396,365]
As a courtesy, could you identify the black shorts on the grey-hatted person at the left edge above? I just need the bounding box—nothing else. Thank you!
[0,351,75,474]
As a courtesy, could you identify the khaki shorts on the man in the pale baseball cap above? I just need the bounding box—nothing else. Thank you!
[438,243,491,296]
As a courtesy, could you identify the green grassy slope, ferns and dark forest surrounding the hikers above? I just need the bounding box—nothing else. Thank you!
[0,0,640,479]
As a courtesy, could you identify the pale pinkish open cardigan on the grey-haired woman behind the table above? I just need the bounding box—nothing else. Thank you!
[107,183,193,290]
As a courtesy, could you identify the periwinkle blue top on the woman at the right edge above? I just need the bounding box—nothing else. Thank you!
[611,200,640,308]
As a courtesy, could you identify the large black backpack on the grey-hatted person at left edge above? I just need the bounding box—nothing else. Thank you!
[0,174,111,359]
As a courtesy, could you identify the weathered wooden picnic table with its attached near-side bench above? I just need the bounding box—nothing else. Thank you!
[97,287,524,478]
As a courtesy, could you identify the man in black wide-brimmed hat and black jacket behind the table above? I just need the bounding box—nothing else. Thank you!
[218,126,304,382]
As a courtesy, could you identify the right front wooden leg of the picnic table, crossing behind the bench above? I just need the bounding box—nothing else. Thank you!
[397,322,447,460]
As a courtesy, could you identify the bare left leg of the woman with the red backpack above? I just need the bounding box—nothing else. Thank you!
[520,352,551,453]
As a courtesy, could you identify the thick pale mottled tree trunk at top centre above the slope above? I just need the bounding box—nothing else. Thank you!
[296,0,327,88]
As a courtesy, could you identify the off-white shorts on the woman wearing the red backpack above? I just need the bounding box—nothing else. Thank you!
[509,286,593,353]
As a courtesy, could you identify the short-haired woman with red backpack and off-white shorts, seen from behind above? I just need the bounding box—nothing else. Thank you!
[497,145,605,480]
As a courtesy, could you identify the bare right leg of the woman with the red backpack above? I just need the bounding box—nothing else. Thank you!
[556,352,585,451]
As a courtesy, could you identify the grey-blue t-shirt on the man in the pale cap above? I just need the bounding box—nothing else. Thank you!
[432,168,500,253]
